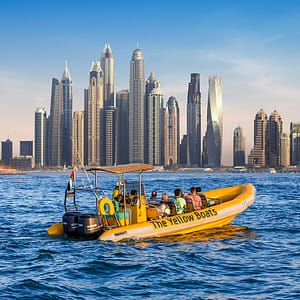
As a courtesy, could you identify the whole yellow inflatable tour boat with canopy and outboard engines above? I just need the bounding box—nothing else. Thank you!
[48,164,256,241]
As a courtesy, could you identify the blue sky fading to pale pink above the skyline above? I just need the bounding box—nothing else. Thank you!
[0,0,300,165]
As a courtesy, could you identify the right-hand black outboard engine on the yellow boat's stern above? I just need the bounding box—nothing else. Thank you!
[78,214,102,239]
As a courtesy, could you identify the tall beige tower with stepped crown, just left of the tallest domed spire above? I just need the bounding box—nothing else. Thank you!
[84,61,103,166]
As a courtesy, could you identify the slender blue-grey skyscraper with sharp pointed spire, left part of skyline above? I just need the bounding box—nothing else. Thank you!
[61,64,73,166]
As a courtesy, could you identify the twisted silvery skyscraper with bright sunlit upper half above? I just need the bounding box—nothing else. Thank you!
[203,76,223,168]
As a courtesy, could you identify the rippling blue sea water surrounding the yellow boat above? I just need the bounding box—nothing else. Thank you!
[0,172,300,299]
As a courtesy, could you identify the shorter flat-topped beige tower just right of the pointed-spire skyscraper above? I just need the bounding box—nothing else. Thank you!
[72,111,84,168]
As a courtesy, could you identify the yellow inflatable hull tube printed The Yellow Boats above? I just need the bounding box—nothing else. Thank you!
[99,184,256,241]
